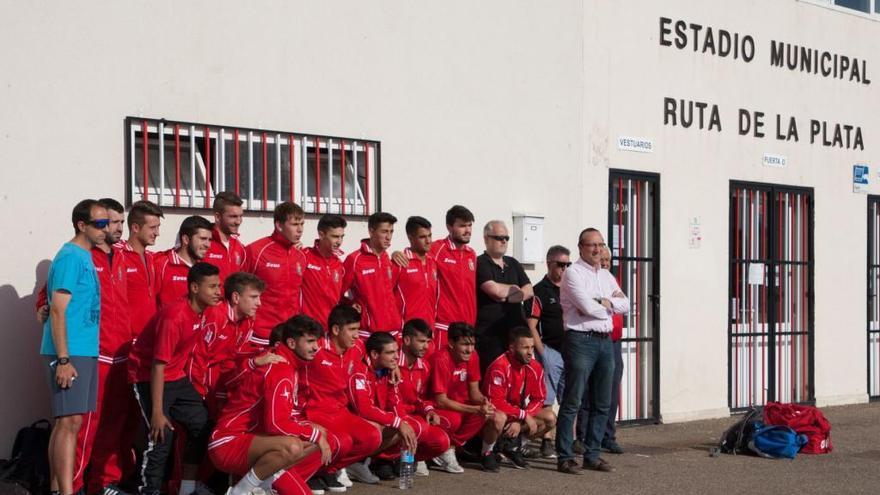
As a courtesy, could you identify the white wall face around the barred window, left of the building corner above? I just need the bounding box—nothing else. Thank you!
[0,0,583,454]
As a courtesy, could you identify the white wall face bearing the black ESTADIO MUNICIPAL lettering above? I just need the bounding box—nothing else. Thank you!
[584,0,880,421]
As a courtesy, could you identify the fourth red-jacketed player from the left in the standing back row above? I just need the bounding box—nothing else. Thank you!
[205,191,246,284]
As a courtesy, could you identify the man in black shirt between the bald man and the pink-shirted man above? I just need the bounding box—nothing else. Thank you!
[525,246,571,459]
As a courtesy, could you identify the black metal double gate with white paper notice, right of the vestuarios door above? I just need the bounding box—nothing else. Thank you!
[728,182,813,410]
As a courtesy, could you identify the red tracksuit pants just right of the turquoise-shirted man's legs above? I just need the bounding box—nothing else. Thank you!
[73,361,140,493]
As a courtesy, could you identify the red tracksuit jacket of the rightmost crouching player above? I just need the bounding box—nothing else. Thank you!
[483,352,547,420]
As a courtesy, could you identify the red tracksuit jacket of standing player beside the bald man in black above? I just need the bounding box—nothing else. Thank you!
[431,237,477,330]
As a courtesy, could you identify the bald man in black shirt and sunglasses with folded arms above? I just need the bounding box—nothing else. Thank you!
[476,220,533,372]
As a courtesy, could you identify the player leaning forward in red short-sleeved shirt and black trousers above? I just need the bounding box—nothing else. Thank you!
[128,262,220,495]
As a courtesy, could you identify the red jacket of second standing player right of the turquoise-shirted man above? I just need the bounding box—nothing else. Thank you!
[115,241,157,339]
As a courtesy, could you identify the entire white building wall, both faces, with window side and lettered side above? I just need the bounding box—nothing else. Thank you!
[0,0,880,454]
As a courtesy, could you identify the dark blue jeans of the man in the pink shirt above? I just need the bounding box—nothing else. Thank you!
[556,330,614,461]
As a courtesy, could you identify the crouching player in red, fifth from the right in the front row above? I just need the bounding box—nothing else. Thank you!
[305,305,382,488]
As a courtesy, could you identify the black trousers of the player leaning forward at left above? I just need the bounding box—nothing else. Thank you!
[134,378,211,495]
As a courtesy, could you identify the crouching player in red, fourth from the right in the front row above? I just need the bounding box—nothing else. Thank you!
[348,332,449,480]
